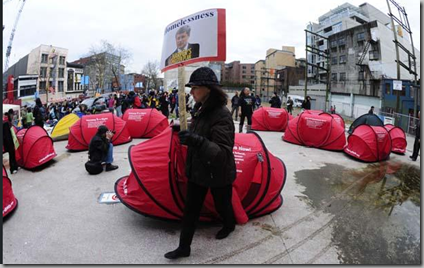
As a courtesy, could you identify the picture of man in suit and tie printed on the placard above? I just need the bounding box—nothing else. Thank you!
[165,25,200,66]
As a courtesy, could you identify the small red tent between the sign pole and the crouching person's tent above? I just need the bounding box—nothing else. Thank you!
[122,109,169,138]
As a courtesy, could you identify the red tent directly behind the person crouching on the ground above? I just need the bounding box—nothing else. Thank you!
[66,113,131,151]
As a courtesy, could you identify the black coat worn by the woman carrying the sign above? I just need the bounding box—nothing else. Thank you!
[186,99,236,187]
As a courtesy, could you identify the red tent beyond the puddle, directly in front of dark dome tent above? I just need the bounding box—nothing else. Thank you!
[344,125,392,162]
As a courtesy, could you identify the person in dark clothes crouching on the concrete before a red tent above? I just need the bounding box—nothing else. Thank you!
[88,125,118,171]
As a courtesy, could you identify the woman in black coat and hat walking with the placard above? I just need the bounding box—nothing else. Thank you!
[165,67,236,259]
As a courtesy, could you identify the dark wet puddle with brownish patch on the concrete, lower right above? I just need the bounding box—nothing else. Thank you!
[295,161,421,264]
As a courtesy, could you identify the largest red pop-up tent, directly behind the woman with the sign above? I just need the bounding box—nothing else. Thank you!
[115,128,286,223]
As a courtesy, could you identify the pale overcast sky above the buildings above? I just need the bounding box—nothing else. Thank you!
[3,0,421,73]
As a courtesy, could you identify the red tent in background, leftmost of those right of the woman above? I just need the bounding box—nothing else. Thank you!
[252,107,290,131]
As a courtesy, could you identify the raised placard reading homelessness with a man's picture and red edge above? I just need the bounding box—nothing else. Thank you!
[160,9,226,72]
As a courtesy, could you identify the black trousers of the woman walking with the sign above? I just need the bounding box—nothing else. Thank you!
[179,182,236,248]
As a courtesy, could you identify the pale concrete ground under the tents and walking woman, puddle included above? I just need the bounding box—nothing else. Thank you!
[3,125,421,264]
